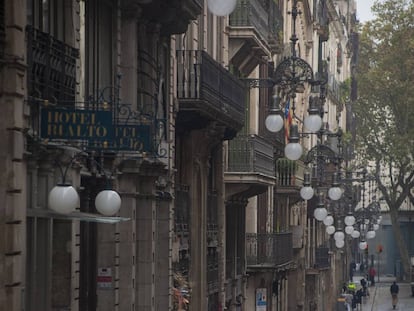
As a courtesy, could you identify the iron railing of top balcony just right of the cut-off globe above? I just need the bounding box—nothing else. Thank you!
[229,0,283,45]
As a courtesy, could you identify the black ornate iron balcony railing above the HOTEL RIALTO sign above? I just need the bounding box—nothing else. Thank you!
[27,27,79,101]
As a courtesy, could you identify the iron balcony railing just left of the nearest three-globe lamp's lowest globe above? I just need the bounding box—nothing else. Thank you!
[228,135,275,176]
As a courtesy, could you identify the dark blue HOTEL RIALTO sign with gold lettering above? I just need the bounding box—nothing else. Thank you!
[40,107,151,152]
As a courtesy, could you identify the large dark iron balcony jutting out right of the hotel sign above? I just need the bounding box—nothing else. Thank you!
[177,50,247,139]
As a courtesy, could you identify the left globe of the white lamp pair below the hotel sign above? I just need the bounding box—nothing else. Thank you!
[48,184,79,214]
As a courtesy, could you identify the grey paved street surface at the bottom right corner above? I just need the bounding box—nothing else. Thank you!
[354,276,414,311]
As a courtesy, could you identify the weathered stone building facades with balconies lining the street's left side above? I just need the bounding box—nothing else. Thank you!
[0,0,354,311]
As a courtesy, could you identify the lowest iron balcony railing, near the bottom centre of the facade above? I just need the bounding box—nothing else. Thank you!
[246,232,293,267]
